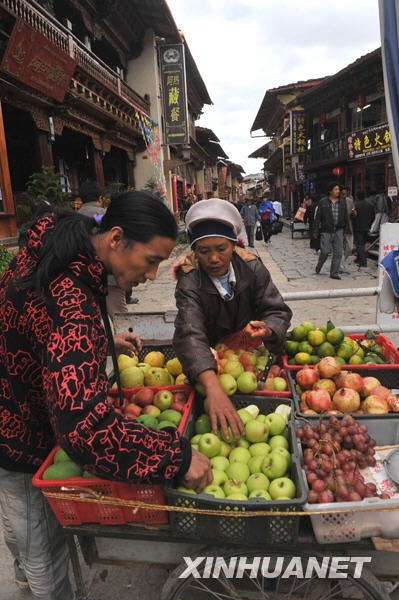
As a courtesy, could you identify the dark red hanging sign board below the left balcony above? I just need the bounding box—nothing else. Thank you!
[0,17,76,102]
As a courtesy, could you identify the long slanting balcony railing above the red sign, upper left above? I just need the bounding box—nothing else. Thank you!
[0,0,149,113]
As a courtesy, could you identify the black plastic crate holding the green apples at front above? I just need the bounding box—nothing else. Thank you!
[164,395,306,544]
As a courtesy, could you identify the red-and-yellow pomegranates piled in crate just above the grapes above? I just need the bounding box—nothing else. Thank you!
[296,356,399,415]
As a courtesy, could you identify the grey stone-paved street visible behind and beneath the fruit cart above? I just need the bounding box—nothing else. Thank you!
[0,223,395,600]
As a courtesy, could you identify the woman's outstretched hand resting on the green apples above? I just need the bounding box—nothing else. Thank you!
[199,371,245,440]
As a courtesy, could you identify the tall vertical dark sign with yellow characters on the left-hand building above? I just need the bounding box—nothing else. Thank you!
[159,44,190,144]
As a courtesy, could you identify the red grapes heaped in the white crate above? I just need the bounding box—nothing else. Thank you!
[296,415,389,504]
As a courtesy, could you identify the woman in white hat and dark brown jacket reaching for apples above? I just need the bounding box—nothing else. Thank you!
[173,198,292,437]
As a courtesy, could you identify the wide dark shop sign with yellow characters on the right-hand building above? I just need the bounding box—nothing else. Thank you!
[347,123,392,160]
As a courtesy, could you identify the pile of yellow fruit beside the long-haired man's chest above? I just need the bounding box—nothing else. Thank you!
[114,351,189,388]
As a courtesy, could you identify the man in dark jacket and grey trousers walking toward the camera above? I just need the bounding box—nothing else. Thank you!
[313,183,350,279]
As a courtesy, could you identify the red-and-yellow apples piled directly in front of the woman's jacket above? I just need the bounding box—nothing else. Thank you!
[196,343,288,396]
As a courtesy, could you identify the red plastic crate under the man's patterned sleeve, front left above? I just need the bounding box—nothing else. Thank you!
[32,446,169,525]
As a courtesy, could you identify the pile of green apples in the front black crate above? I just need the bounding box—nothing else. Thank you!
[178,405,296,501]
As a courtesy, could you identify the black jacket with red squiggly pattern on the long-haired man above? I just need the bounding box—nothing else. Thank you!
[0,216,191,483]
